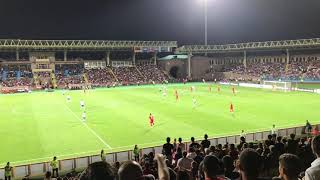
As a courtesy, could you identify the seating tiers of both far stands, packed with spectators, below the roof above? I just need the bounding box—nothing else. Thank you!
[0,53,320,88]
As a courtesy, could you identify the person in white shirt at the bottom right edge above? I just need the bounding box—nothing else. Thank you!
[305,135,320,180]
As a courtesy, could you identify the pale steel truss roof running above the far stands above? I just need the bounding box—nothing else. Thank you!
[0,38,320,53]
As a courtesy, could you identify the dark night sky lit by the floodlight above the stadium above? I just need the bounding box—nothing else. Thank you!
[0,0,320,45]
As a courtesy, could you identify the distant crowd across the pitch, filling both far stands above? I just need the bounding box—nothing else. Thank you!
[0,55,320,87]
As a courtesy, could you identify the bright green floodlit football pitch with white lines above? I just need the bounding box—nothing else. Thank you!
[0,83,320,165]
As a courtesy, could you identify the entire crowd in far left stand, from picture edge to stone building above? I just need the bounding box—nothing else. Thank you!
[0,64,166,87]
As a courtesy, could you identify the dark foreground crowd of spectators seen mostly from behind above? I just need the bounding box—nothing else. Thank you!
[27,132,320,180]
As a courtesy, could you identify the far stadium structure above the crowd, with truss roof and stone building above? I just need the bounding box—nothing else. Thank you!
[0,38,320,88]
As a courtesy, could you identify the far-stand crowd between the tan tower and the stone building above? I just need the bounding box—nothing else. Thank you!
[55,65,166,87]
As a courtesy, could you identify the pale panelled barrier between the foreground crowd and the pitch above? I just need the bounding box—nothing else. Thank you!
[0,126,312,178]
